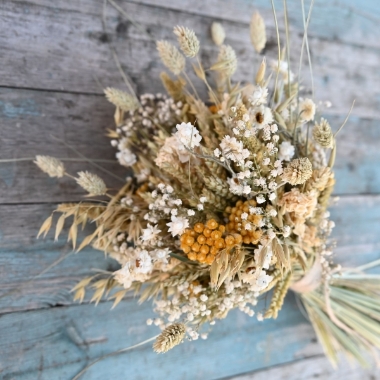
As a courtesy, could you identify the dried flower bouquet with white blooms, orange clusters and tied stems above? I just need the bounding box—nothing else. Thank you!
[35,13,380,364]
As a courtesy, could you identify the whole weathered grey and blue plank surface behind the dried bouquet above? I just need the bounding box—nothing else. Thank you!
[0,0,380,380]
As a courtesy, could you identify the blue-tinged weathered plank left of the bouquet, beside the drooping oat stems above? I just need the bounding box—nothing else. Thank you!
[0,204,118,314]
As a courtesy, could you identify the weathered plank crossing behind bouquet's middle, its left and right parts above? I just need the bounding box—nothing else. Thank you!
[0,88,380,203]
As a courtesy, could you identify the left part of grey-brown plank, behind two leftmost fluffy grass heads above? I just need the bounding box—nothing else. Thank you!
[0,88,127,203]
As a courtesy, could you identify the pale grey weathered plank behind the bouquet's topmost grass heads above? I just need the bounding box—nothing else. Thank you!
[0,0,380,118]
